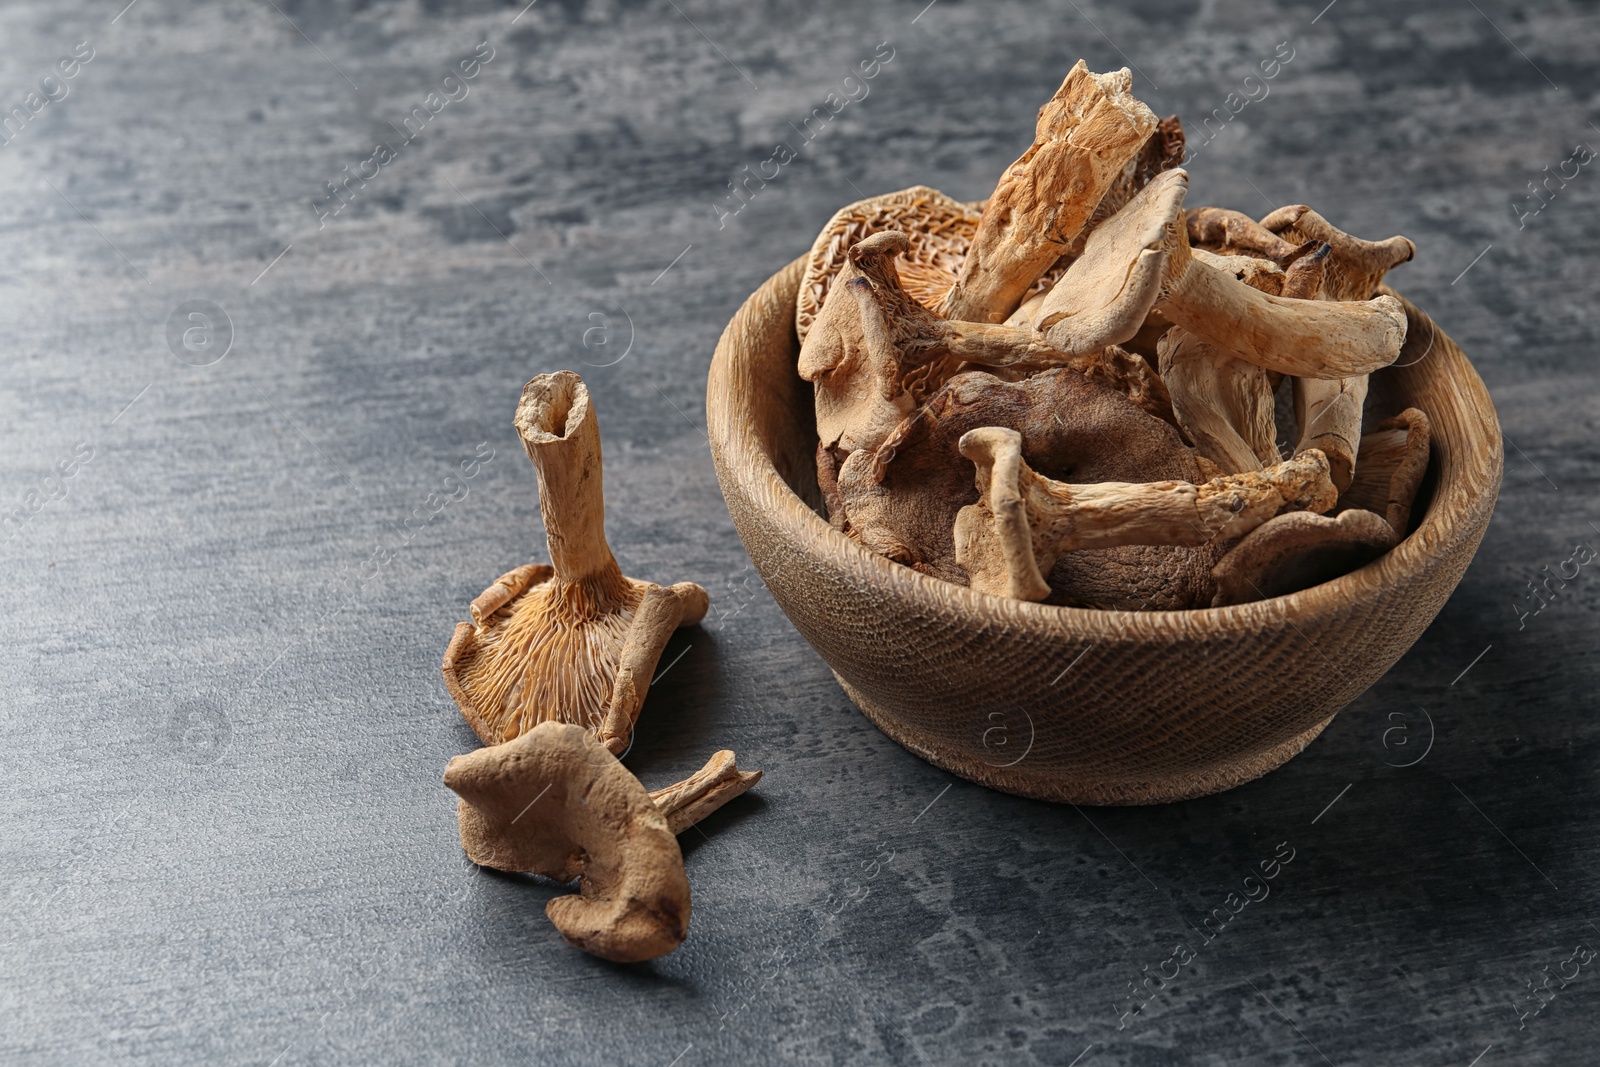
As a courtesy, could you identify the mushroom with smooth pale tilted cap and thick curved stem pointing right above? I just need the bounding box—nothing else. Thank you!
[1062,170,1406,378]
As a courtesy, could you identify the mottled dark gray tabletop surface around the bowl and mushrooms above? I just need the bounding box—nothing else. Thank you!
[0,0,1600,1067]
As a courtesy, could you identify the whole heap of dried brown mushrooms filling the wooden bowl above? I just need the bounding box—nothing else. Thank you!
[795,61,1430,609]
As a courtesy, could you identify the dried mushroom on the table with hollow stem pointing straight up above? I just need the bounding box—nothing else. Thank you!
[443,371,707,752]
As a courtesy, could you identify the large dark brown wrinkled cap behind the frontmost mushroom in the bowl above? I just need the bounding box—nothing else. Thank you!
[838,368,1214,609]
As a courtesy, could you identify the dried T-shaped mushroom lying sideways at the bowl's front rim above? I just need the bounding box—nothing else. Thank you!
[955,427,1338,600]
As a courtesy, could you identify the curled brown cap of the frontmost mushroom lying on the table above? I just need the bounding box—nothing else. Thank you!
[445,721,690,963]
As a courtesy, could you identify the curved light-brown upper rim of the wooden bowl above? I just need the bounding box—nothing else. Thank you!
[706,254,1504,641]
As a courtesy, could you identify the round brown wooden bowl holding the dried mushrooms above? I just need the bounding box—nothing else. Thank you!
[706,259,1502,805]
